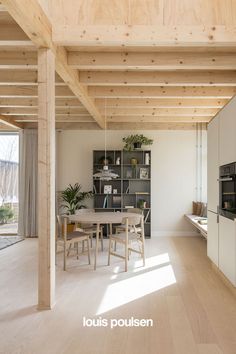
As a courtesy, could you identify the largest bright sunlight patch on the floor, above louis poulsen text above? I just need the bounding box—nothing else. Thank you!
[96,264,176,315]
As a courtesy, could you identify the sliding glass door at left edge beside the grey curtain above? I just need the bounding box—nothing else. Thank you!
[0,133,19,235]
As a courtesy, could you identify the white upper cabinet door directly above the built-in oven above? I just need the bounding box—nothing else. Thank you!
[219,97,236,165]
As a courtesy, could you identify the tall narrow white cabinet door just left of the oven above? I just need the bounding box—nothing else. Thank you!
[207,113,220,213]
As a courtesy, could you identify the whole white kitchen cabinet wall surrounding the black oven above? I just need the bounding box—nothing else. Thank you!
[207,97,236,286]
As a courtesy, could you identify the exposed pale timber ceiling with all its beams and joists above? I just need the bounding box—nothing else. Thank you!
[0,0,236,130]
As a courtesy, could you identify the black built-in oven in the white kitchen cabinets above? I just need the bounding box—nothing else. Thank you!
[219,162,236,220]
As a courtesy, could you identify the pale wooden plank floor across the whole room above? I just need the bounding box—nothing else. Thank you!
[0,237,236,354]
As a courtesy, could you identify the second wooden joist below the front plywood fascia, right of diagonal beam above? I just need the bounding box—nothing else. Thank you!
[79,70,236,86]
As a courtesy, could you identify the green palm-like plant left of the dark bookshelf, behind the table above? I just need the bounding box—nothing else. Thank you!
[61,183,93,214]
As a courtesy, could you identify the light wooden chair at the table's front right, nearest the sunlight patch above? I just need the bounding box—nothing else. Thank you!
[108,215,145,272]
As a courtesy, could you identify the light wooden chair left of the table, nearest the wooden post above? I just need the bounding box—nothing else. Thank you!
[56,215,91,270]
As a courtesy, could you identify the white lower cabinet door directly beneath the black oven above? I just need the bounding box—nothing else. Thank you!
[219,216,236,286]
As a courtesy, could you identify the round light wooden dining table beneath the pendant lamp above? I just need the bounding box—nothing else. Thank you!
[69,211,142,270]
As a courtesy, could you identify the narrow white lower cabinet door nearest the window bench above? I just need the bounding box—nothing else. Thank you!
[207,211,219,267]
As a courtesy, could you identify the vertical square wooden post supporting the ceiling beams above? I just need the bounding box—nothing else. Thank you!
[38,48,55,310]
